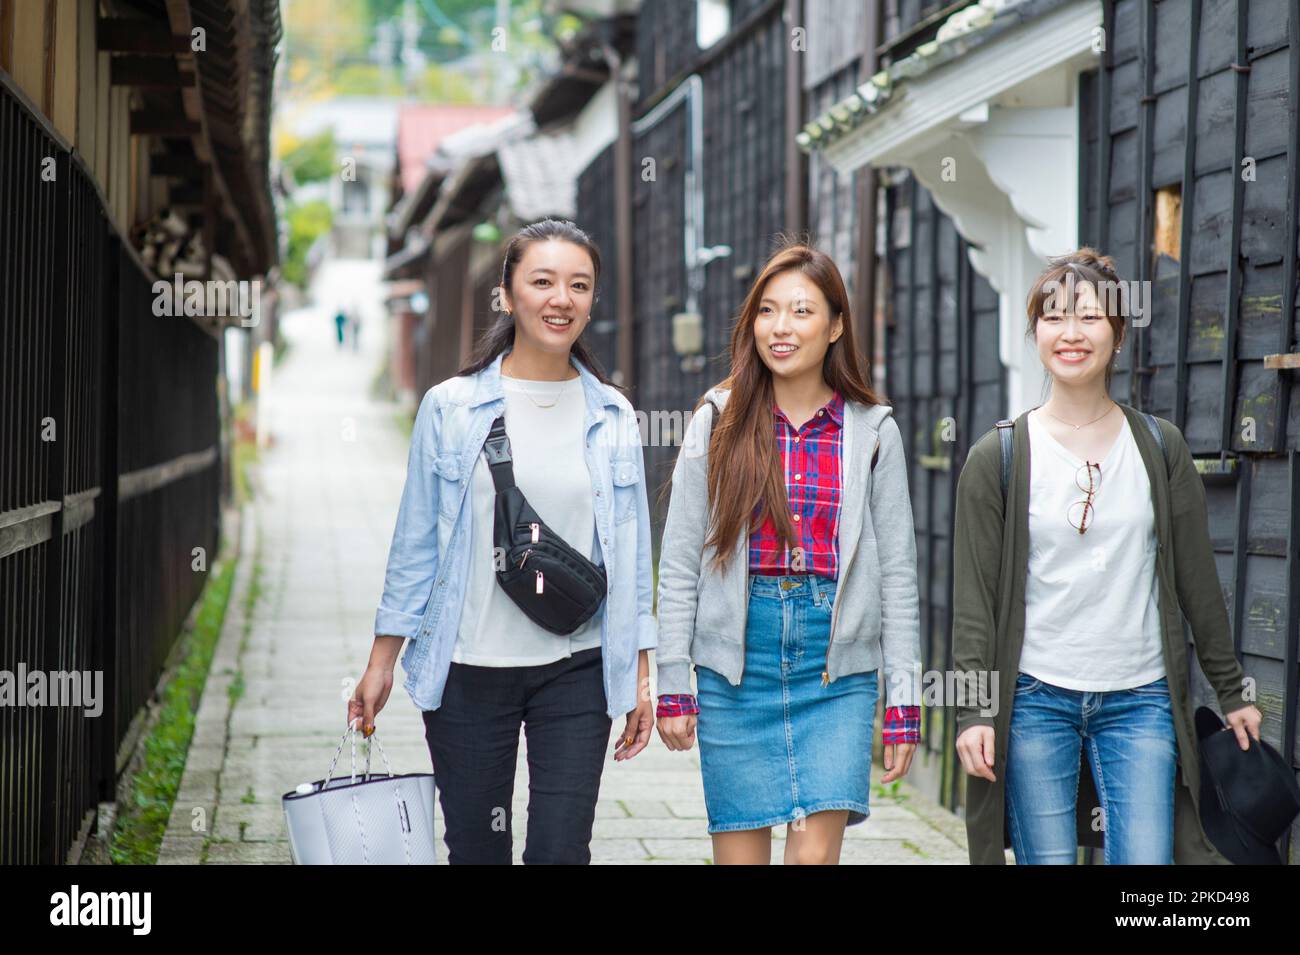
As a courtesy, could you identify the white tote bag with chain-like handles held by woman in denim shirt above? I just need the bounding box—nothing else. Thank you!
[280,720,437,865]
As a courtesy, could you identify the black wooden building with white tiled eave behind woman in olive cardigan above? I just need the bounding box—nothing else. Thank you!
[801,0,1300,859]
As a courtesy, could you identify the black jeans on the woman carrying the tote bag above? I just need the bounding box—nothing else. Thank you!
[424,647,612,865]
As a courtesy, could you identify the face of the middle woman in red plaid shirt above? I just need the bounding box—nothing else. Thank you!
[754,269,844,378]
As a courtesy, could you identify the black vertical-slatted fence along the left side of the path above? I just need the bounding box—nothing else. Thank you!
[0,77,220,864]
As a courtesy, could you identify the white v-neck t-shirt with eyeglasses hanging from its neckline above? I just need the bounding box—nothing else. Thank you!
[1019,411,1166,693]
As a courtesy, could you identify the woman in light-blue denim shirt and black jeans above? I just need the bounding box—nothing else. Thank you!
[348,220,655,864]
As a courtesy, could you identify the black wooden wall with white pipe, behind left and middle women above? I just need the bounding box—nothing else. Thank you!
[626,0,789,529]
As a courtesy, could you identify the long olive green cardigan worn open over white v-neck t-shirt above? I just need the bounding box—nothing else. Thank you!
[953,404,1248,864]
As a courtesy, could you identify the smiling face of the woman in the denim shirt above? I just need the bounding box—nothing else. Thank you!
[506,239,595,355]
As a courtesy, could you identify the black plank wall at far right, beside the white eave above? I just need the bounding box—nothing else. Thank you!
[1080,0,1300,858]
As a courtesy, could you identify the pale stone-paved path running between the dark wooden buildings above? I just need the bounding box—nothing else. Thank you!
[159,276,966,864]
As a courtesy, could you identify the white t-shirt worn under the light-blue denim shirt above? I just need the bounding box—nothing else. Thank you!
[451,376,603,667]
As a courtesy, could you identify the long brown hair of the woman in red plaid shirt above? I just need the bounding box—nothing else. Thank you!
[696,236,883,570]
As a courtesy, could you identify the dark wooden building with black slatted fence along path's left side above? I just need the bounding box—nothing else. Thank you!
[0,0,280,864]
